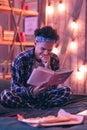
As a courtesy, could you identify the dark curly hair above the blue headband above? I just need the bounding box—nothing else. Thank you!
[34,26,59,42]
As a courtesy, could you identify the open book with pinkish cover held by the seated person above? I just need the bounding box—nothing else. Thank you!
[27,67,73,86]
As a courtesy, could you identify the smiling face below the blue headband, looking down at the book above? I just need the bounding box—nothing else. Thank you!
[35,42,54,63]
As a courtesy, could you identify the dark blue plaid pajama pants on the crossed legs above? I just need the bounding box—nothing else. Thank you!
[0,86,70,108]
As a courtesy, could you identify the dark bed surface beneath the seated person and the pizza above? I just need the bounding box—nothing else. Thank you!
[0,79,87,130]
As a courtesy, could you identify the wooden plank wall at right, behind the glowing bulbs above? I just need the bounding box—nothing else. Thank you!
[47,0,87,94]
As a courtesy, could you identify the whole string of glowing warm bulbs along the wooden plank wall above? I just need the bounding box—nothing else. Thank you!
[46,0,87,87]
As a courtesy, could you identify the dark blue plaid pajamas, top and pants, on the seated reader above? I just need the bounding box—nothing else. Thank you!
[1,48,70,108]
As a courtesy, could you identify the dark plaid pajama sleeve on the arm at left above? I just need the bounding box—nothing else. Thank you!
[11,54,33,97]
